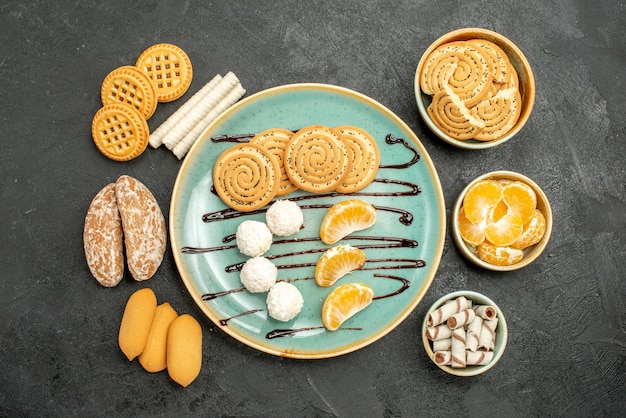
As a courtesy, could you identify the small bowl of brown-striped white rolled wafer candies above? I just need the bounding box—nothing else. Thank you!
[422,290,508,376]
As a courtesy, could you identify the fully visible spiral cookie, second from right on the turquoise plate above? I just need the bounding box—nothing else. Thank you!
[284,125,350,193]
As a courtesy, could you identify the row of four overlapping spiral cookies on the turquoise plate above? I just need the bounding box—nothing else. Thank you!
[213,125,380,212]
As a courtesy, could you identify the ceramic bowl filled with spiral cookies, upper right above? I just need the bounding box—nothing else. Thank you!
[415,28,535,150]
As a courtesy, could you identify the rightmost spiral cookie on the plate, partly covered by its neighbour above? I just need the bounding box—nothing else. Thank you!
[335,126,380,193]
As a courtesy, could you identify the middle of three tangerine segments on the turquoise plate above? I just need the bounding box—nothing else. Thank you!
[315,245,365,287]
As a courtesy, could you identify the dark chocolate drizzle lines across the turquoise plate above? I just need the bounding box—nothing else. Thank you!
[181,133,426,340]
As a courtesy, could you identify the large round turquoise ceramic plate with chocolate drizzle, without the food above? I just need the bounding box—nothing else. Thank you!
[170,84,446,359]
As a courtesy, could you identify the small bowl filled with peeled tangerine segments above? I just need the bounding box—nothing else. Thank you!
[452,171,552,271]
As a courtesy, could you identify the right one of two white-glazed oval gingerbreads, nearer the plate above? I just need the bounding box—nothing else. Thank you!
[115,175,167,281]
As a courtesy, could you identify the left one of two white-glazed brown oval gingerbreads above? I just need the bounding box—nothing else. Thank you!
[83,183,124,287]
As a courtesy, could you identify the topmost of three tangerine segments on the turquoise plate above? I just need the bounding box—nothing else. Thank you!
[320,199,376,245]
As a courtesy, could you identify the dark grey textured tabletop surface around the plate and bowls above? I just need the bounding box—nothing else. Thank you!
[0,0,626,417]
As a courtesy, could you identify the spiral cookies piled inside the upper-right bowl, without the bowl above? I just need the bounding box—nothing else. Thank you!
[419,39,522,141]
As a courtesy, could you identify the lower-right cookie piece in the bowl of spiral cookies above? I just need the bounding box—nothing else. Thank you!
[471,88,522,141]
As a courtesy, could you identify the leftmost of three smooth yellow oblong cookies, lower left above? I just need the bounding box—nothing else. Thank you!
[118,288,157,361]
